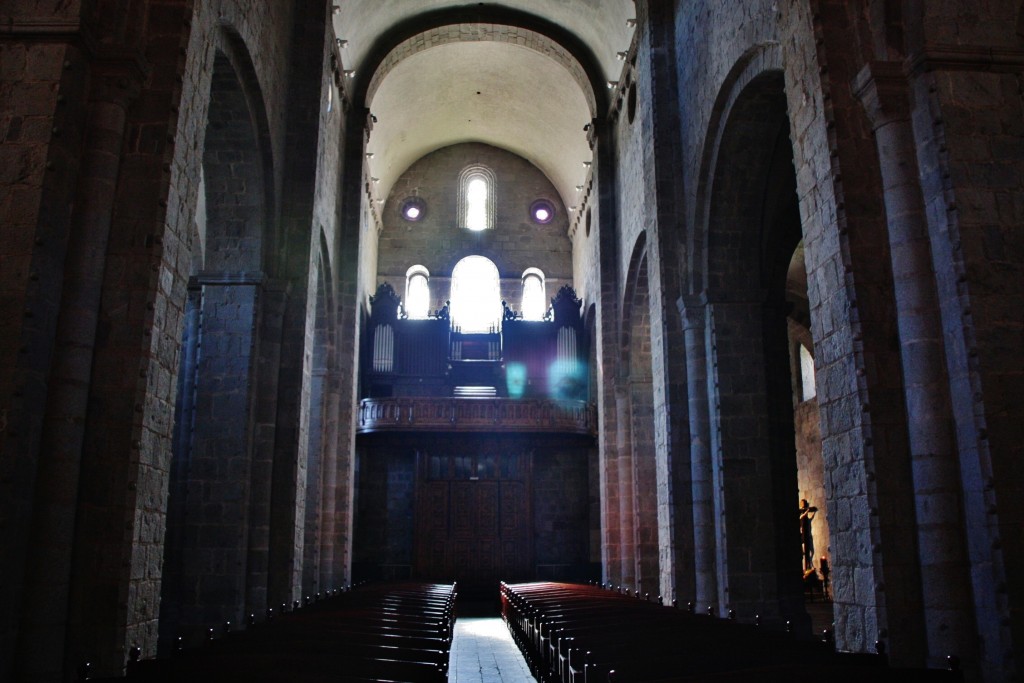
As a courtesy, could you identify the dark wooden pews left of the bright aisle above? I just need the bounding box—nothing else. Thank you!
[86,583,456,683]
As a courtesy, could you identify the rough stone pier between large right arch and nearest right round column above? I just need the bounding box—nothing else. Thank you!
[779,2,923,663]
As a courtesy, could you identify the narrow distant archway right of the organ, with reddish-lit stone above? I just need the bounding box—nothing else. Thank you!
[616,232,660,595]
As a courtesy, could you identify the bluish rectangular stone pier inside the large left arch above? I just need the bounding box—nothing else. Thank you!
[180,274,262,633]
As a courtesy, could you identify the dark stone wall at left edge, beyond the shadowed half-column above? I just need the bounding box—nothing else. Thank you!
[0,28,90,678]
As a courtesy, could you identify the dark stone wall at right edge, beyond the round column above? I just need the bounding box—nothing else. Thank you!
[909,2,1024,680]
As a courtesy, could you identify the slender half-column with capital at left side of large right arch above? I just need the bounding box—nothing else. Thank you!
[679,297,724,605]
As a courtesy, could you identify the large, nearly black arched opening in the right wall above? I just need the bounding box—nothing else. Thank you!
[696,68,805,621]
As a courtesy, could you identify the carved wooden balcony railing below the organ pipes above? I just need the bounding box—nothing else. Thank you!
[356,397,597,435]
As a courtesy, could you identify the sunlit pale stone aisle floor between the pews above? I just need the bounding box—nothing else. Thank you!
[449,616,536,683]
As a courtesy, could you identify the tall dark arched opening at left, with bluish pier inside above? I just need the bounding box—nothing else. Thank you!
[160,28,273,647]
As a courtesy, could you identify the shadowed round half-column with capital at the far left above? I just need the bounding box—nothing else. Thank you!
[18,58,141,677]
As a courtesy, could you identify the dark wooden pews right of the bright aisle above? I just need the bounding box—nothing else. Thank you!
[501,582,963,683]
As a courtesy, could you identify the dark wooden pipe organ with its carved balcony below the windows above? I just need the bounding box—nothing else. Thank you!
[356,284,597,436]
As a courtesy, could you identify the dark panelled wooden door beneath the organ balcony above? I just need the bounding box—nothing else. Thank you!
[415,455,534,591]
